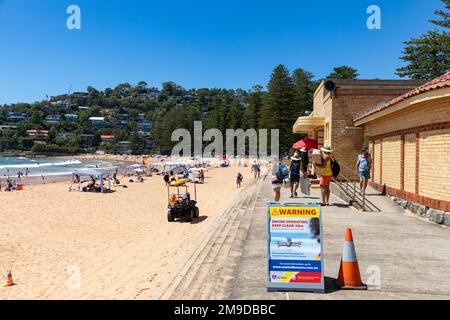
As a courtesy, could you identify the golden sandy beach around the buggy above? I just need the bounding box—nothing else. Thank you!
[0,159,253,299]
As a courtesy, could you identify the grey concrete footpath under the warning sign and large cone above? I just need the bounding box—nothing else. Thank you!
[229,181,450,300]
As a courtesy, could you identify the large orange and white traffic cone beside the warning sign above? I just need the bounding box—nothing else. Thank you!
[335,228,367,290]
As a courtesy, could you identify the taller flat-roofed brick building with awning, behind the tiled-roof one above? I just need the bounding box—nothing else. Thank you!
[294,79,423,178]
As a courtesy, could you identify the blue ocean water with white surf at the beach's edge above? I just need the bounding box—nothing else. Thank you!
[0,156,117,177]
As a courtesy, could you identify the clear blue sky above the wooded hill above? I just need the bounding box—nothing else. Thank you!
[0,0,442,104]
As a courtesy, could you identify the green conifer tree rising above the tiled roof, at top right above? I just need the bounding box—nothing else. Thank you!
[397,0,450,80]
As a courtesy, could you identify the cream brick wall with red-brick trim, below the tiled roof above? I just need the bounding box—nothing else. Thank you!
[364,97,450,211]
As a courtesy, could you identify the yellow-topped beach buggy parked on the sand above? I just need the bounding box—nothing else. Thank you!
[167,179,200,222]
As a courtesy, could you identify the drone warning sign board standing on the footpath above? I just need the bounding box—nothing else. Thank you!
[267,203,325,293]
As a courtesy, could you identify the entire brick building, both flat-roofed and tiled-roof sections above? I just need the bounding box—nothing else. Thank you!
[294,72,450,216]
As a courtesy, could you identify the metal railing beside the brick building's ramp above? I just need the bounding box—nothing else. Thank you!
[334,163,381,212]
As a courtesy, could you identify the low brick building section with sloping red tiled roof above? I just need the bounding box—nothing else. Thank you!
[353,72,450,212]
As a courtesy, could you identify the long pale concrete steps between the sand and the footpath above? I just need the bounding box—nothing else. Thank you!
[157,181,261,300]
